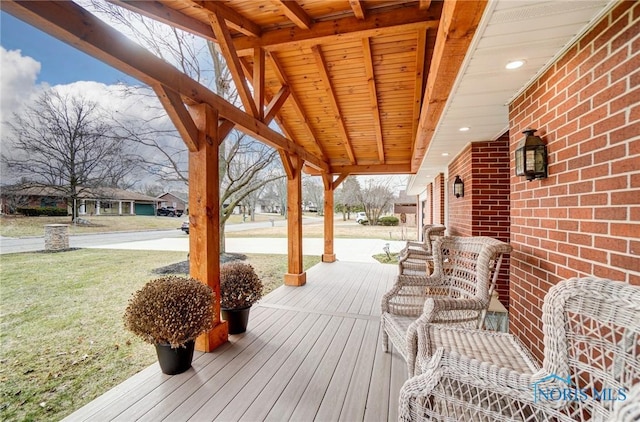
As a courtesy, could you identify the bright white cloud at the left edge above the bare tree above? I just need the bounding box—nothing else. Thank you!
[0,46,41,122]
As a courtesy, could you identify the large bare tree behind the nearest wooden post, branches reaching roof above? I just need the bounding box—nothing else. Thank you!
[92,1,284,253]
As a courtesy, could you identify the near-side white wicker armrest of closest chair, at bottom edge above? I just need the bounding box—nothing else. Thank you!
[399,348,570,421]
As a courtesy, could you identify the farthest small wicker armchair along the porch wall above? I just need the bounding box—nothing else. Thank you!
[398,224,447,275]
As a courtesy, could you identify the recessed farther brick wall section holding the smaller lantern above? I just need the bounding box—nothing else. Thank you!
[447,136,510,307]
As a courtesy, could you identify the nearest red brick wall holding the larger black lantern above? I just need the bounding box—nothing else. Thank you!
[509,2,640,358]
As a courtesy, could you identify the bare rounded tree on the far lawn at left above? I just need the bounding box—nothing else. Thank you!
[2,91,138,219]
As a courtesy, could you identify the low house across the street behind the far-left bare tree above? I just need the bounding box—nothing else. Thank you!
[0,186,156,215]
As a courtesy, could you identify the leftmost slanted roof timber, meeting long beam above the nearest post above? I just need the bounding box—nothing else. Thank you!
[209,13,260,118]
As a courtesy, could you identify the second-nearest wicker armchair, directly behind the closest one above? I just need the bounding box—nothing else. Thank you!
[381,236,511,376]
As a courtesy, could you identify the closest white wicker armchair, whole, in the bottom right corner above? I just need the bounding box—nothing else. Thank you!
[399,278,640,422]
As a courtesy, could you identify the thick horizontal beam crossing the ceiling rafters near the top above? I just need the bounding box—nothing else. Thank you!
[234,2,442,56]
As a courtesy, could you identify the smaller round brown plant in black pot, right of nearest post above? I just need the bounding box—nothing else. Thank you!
[220,262,263,334]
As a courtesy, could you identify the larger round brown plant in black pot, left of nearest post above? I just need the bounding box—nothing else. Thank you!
[124,276,213,375]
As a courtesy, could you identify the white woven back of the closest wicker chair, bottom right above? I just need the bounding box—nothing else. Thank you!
[542,278,640,421]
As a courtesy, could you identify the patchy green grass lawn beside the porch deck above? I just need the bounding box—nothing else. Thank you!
[0,249,320,421]
